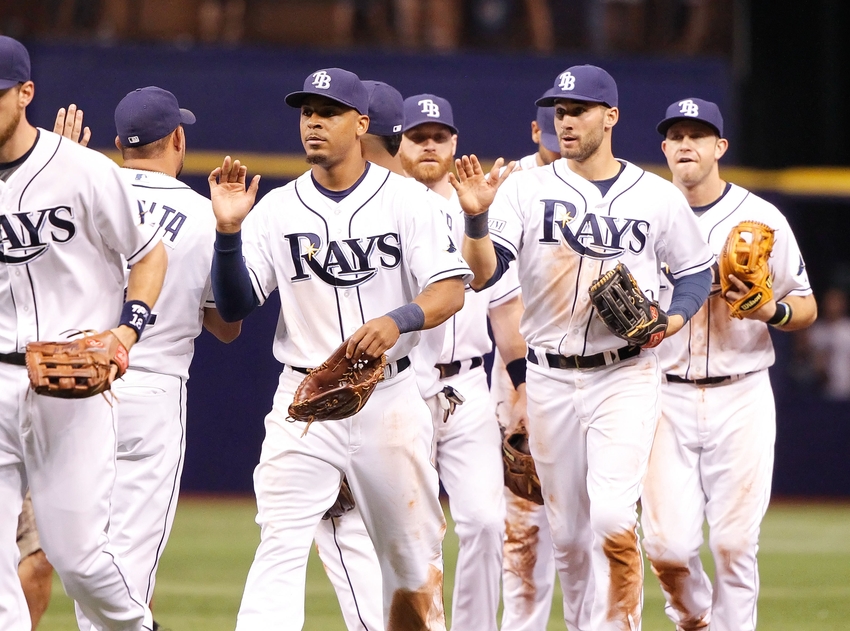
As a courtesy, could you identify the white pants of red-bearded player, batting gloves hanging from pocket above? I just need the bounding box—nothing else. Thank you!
[426,367,505,631]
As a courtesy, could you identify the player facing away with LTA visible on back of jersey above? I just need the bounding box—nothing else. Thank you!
[56,86,241,629]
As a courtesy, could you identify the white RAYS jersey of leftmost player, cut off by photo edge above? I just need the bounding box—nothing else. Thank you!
[0,129,157,353]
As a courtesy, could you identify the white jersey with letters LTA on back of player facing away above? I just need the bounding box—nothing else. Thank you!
[121,169,215,378]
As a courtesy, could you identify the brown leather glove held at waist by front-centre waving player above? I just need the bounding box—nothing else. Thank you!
[289,342,387,433]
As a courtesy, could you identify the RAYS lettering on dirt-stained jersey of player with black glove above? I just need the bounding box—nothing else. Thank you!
[540,199,649,260]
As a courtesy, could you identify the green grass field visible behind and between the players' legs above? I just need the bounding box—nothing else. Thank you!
[39,498,850,631]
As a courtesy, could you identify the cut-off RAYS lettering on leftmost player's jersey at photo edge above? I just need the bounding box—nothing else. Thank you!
[0,206,77,265]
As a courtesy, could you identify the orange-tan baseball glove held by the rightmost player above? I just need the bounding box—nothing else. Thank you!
[717,221,773,319]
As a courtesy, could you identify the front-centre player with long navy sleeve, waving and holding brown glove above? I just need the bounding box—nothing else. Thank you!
[210,68,470,631]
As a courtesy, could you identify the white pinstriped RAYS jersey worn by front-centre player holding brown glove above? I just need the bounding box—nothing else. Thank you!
[243,164,472,367]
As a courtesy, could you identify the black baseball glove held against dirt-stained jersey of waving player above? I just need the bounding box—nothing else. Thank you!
[589,263,667,348]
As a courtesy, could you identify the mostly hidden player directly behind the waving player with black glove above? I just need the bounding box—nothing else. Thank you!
[490,94,561,631]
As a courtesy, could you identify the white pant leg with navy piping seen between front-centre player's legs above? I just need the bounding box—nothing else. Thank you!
[316,506,384,631]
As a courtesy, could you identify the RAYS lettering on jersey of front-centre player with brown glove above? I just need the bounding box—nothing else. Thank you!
[283,232,401,287]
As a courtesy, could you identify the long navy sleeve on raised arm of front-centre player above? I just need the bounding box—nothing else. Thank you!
[211,231,260,322]
